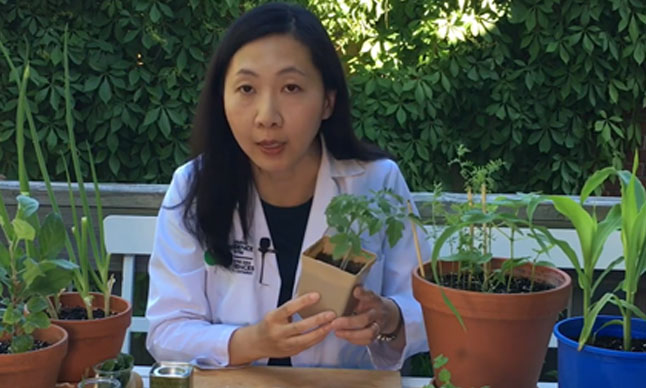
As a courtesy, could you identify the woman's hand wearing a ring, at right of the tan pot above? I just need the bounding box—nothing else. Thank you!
[332,286,402,345]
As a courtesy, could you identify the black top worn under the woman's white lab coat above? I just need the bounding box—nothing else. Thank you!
[261,198,312,366]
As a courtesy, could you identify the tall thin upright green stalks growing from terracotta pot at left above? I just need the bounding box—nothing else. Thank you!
[0,27,115,319]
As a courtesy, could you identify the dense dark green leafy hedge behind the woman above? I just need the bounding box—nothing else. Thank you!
[0,0,646,193]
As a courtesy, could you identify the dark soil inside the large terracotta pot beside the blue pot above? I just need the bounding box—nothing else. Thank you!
[425,272,554,294]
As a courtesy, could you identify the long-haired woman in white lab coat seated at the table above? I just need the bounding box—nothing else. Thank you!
[146,3,428,369]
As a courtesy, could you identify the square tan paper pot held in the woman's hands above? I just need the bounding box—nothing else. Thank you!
[296,236,377,318]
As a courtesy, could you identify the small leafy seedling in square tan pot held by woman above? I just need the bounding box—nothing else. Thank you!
[297,189,408,318]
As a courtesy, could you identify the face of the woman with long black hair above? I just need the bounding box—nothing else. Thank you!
[224,35,335,175]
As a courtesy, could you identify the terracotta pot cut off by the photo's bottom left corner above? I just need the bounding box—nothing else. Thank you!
[0,325,68,388]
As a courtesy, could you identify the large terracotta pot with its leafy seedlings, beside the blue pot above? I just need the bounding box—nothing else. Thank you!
[413,146,571,388]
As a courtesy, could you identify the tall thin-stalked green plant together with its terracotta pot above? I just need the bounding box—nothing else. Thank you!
[1,27,132,382]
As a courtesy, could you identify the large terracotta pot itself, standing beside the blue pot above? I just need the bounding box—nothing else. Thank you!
[413,259,571,388]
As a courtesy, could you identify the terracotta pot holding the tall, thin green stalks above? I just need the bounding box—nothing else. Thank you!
[52,292,132,383]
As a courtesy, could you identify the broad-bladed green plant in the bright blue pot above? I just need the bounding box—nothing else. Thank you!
[552,152,646,388]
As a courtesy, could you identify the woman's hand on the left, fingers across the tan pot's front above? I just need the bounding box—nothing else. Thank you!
[229,292,336,365]
